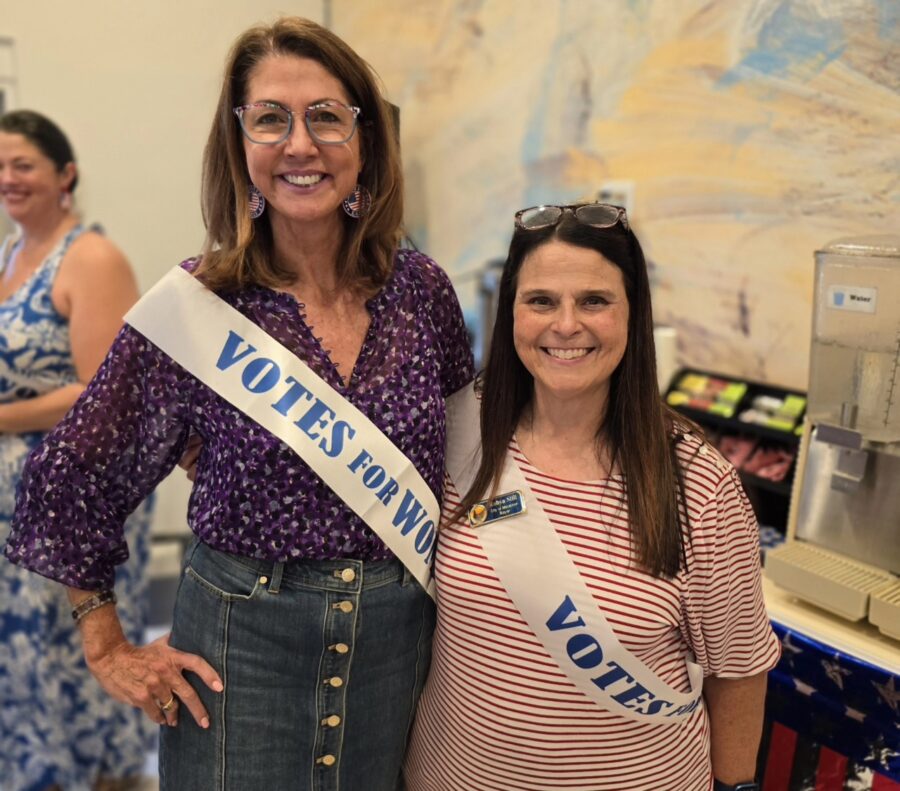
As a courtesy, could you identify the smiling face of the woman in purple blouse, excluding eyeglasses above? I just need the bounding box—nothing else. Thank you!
[244,55,363,235]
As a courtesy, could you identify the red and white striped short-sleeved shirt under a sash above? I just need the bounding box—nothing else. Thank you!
[405,436,779,791]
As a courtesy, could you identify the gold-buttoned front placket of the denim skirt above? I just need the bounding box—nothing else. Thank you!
[315,567,360,791]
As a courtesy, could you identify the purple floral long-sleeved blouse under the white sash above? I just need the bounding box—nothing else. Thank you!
[5,250,473,590]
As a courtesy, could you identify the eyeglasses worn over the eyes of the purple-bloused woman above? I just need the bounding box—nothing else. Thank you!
[233,100,361,146]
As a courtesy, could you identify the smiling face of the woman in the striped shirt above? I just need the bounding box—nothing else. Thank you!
[513,239,629,409]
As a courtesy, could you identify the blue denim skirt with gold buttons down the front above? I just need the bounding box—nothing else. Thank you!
[159,541,435,791]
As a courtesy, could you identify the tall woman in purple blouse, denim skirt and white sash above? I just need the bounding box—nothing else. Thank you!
[6,18,472,791]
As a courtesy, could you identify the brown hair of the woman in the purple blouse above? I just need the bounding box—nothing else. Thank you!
[197,17,403,293]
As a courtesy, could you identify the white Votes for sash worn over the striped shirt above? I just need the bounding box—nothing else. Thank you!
[447,385,703,724]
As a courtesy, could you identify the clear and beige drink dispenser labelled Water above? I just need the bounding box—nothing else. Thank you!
[766,236,900,639]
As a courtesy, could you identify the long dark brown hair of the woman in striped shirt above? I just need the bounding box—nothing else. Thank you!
[457,213,688,577]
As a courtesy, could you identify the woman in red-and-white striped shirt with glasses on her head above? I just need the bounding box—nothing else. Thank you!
[405,204,779,791]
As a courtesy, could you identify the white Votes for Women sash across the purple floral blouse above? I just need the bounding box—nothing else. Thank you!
[125,267,440,596]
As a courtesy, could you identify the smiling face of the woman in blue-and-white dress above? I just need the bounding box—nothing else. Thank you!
[0,132,75,226]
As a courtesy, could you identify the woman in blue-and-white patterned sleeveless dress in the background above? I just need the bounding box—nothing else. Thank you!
[0,110,150,791]
